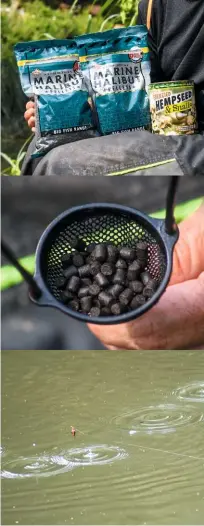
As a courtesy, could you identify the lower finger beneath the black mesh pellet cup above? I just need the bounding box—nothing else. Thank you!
[88,272,204,350]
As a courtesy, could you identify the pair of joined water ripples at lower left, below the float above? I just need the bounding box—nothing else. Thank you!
[1,445,128,479]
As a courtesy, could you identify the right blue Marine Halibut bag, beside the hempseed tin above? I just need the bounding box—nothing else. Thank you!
[77,26,151,135]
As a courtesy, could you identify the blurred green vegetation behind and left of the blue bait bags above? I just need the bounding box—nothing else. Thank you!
[1,0,139,173]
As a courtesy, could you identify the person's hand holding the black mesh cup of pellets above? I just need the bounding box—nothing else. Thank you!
[88,204,204,350]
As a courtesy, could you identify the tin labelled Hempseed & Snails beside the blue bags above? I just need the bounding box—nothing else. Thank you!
[149,81,197,135]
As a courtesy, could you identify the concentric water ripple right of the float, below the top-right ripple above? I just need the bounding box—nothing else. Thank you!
[114,404,204,435]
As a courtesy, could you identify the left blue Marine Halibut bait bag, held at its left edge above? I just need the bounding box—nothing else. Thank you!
[14,40,93,157]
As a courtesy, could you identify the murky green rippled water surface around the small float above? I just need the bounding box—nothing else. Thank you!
[1,351,204,525]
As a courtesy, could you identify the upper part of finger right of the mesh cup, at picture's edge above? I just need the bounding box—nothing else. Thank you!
[170,204,204,285]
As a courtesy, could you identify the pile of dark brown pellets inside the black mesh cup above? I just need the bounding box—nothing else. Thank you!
[55,239,158,317]
